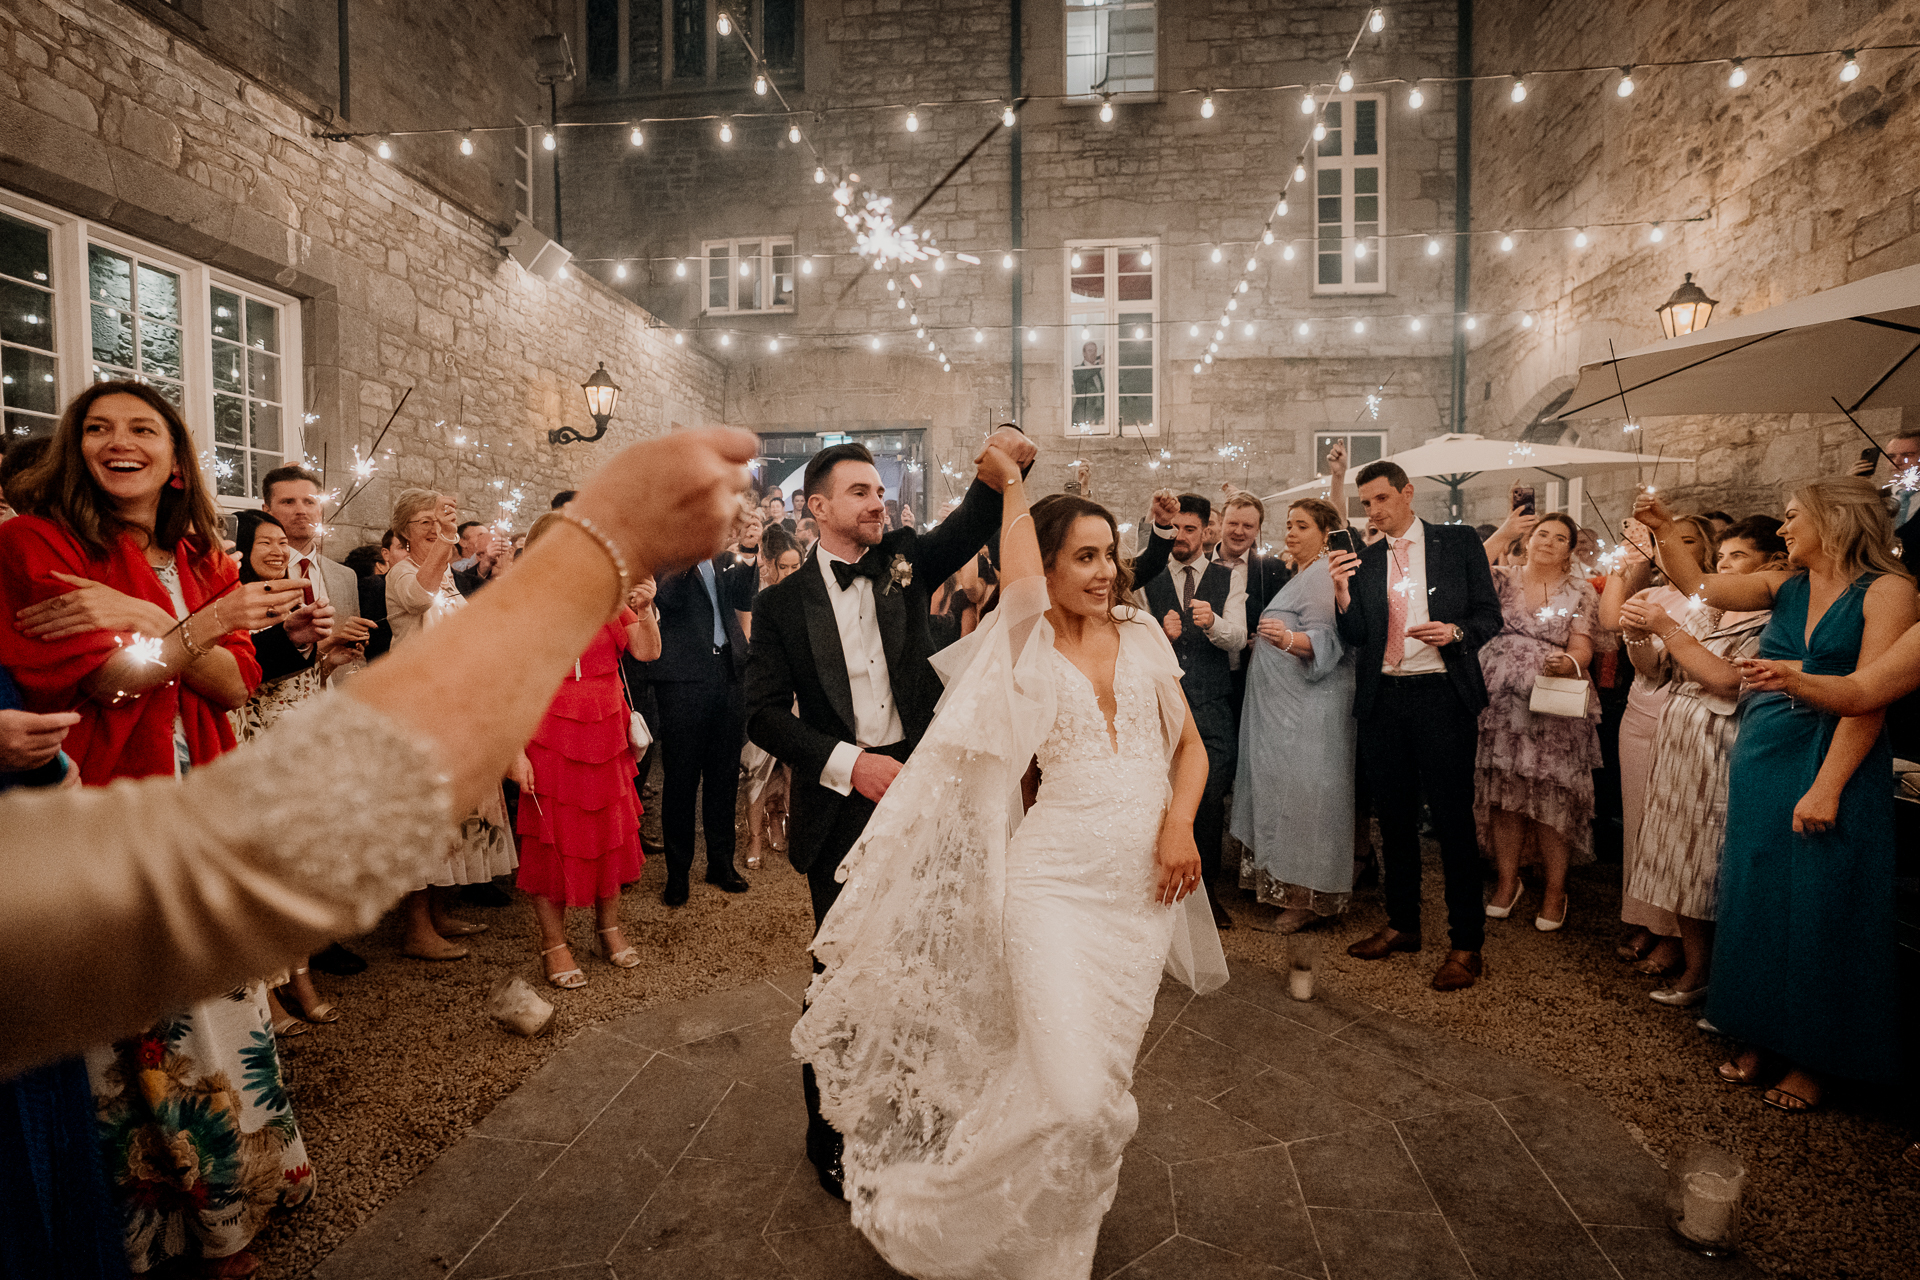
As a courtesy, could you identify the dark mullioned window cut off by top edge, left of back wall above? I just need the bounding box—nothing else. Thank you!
[580,0,801,94]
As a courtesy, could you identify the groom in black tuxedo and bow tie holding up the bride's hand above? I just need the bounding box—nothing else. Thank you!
[747,426,1035,1196]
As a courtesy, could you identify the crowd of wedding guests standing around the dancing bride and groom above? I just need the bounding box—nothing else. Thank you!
[0,382,1920,1274]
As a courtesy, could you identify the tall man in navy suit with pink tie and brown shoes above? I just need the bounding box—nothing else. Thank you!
[1329,459,1501,990]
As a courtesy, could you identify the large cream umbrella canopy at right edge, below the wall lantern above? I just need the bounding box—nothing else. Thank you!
[1559,267,1920,418]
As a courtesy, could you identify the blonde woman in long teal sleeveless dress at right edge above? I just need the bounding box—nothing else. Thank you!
[1634,478,1920,1111]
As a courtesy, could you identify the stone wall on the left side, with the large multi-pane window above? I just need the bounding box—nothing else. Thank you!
[0,0,726,545]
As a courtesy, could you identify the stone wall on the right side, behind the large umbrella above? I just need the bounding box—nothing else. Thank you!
[1469,0,1920,522]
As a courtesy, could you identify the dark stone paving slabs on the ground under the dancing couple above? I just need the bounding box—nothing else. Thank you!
[313,963,1759,1280]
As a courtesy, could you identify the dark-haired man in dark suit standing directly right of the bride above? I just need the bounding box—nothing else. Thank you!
[1133,493,1246,929]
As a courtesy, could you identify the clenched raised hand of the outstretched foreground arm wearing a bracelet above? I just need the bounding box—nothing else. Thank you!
[568,426,760,581]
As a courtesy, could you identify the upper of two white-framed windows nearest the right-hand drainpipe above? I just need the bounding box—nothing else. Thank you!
[1313,96,1386,294]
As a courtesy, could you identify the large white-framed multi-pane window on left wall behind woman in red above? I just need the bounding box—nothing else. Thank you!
[0,194,301,509]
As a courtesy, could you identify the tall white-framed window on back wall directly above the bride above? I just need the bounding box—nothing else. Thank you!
[1064,242,1160,436]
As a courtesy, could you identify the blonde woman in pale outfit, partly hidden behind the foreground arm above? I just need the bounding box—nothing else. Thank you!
[386,489,528,960]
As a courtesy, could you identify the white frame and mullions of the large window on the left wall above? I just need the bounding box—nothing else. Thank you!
[0,188,305,510]
